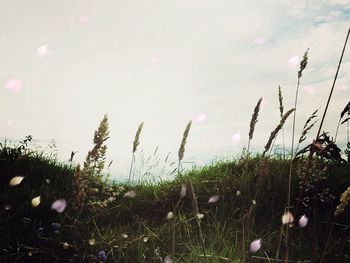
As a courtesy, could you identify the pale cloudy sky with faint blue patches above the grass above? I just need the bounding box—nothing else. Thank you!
[0,0,350,180]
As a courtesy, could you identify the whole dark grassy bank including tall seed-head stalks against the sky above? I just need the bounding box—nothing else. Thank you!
[0,27,350,263]
